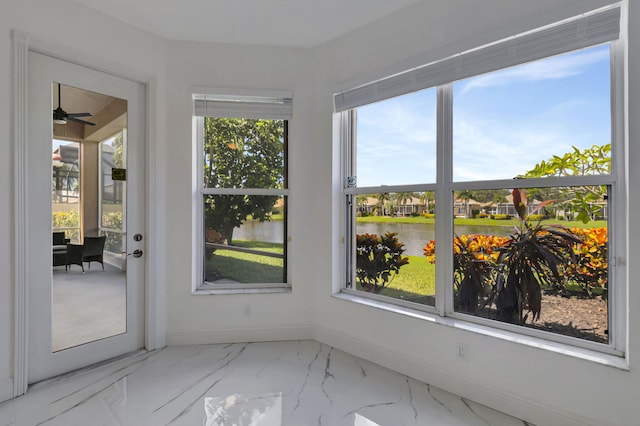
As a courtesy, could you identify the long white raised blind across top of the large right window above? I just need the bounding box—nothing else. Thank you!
[334,7,620,112]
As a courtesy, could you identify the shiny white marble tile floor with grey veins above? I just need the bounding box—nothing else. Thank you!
[0,341,528,426]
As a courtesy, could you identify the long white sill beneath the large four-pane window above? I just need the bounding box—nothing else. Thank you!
[333,292,629,371]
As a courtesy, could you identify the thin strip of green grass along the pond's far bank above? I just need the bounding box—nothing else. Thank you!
[356,216,607,228]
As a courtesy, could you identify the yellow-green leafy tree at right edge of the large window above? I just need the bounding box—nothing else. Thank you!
[519,144,611,223]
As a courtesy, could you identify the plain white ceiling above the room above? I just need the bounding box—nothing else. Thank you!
[76,0,421,47]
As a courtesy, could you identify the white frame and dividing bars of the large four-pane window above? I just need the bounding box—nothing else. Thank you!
[336,6,629,357]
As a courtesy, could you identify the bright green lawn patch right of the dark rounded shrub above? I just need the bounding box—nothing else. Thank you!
[357,256,436,304]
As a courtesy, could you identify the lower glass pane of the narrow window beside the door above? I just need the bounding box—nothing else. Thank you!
[204,195,287,285]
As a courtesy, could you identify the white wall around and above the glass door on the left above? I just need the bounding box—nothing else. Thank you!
[0,0,164,400]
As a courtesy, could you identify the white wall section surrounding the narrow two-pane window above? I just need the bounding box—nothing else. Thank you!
[166,42,317,344]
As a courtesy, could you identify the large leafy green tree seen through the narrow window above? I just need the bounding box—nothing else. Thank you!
[203,118,286,244]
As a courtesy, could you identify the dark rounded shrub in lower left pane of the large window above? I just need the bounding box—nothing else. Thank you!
[356,232,409,293]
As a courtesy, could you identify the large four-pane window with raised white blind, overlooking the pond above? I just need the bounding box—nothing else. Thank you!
[336,8,626,354]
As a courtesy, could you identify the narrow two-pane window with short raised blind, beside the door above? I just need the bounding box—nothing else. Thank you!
[194,95,291,292]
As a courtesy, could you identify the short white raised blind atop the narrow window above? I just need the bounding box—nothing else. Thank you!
[193,95,293,120]
